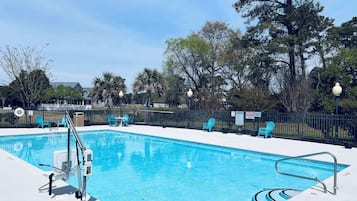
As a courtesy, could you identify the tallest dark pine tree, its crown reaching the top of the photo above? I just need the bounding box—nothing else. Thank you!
[234,0,332,111]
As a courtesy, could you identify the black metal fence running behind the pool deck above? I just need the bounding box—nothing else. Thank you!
[0,107,357,147]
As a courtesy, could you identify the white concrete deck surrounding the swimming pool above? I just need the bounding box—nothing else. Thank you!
[0,125,357,201]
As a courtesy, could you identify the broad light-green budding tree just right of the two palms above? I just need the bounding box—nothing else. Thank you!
[165,22,239,108]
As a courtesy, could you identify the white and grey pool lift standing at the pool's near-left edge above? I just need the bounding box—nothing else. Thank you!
[39,112,93,200]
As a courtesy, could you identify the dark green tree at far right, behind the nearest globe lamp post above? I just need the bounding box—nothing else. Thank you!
[310,17,357,114]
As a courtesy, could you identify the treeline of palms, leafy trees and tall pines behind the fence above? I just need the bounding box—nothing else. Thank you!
[0,0,357,114]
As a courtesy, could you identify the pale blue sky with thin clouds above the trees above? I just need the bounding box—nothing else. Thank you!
[0,0,357,91]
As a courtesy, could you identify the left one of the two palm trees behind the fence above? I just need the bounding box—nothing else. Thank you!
[92,72,126,109]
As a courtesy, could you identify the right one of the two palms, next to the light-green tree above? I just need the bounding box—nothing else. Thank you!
[133,68,164,107]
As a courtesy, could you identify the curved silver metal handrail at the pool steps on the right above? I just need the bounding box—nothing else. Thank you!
[275,152,337,195]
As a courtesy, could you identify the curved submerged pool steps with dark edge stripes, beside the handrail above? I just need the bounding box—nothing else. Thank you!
[252,188,301,201]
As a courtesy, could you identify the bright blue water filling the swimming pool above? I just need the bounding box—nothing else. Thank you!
[0,130,346,201]
